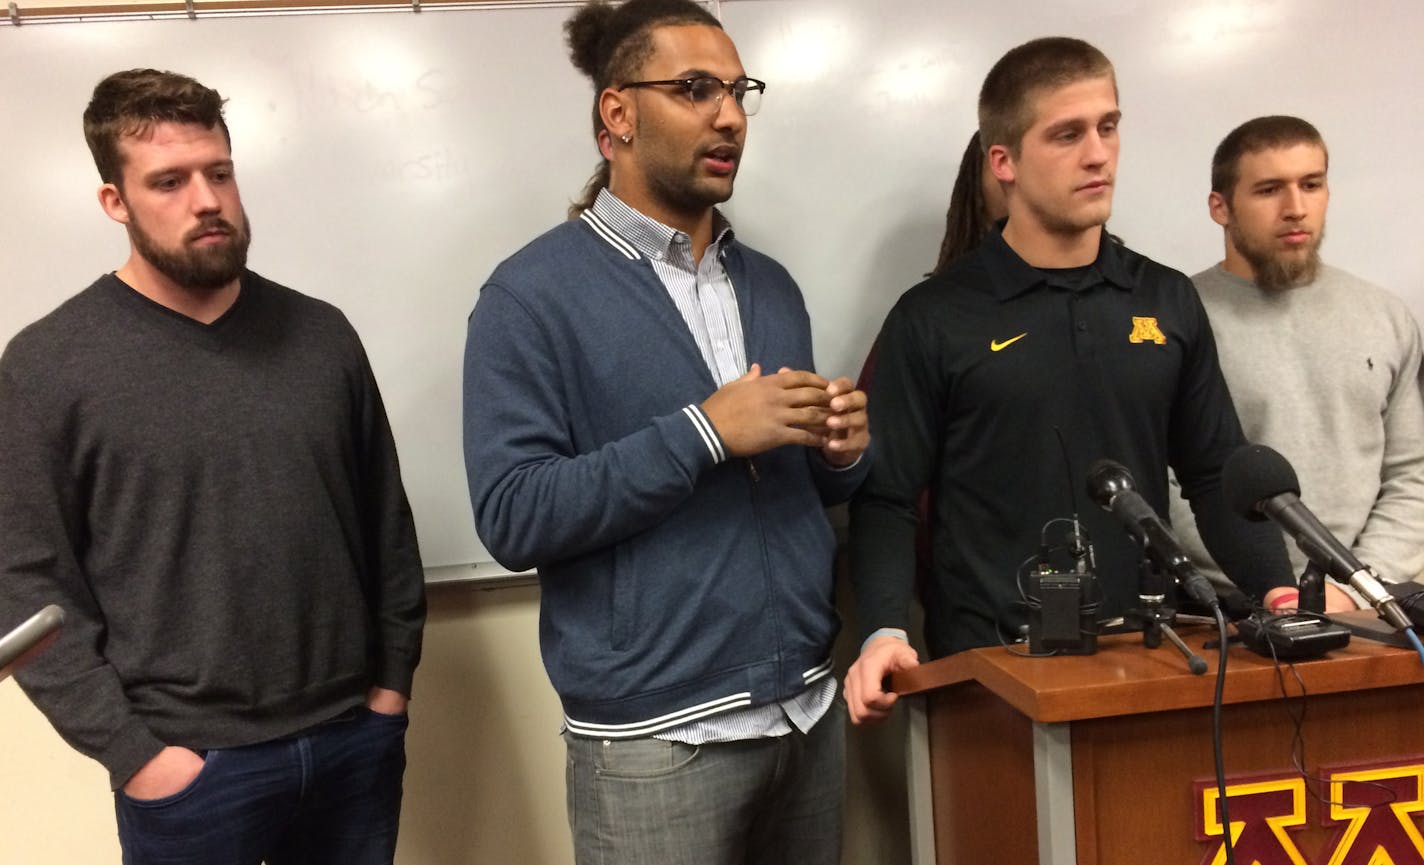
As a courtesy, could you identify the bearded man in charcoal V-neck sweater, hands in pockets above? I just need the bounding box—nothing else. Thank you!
[0,70,424,865]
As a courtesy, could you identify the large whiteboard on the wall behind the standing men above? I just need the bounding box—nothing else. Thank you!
[0,0,1424,575]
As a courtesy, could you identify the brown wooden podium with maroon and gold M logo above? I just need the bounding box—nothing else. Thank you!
[894,613,1424,865]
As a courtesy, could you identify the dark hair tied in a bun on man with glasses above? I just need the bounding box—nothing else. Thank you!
[564,0,722,219]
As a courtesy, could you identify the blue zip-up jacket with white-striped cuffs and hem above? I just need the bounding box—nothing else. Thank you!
[464,212,870,738]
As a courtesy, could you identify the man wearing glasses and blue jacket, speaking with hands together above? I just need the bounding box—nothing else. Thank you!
[464,0,869,865]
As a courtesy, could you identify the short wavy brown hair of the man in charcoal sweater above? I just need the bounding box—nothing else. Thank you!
[84,68,232,188]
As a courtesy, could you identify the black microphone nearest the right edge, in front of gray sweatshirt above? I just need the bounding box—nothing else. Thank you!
[1222,445,1411,630]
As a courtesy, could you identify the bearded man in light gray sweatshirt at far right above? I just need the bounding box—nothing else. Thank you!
[1173,117,1424,610]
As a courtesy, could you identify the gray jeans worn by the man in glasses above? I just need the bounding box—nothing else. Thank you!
[564,700,846,865]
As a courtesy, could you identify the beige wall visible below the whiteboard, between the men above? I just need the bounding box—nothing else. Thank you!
[0,575,909,865]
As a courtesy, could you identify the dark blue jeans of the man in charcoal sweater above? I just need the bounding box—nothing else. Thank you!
[114,707,407,865]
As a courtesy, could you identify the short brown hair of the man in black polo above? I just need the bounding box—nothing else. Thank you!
[978,36,1118,157]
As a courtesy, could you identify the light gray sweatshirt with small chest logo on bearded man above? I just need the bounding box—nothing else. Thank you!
[1172,265,1424,580]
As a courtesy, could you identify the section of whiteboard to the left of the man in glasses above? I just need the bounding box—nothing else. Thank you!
[0,7,597,567]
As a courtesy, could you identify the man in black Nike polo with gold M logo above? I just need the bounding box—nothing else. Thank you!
[846,38,1293,722]
